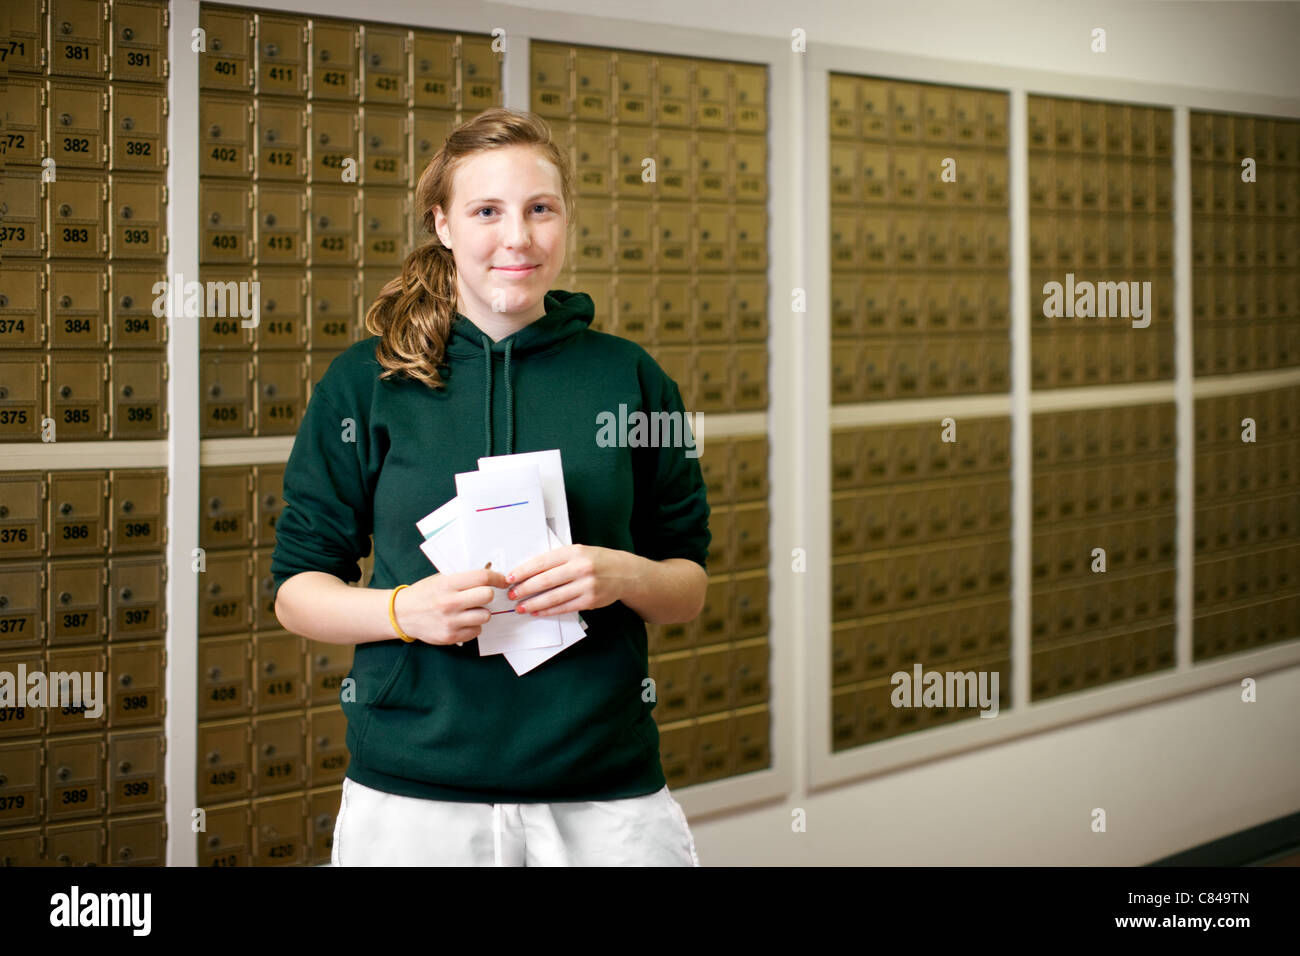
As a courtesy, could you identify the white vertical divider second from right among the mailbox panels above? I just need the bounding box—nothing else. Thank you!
[1006,86,1034,713]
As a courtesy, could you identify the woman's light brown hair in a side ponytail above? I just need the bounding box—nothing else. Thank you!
[365,107,575,389]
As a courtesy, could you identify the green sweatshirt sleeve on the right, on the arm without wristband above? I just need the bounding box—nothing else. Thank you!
[632,359,712,571]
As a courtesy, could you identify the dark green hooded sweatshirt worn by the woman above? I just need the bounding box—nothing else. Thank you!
[272,290,711,803]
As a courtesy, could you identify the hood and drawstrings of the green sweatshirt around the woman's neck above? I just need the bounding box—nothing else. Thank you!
[447,289,595,458]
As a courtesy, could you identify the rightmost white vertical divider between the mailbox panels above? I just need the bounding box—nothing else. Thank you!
[1173,105,1196,672]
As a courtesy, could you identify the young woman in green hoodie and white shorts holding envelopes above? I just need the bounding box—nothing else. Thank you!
[272,108,710,866]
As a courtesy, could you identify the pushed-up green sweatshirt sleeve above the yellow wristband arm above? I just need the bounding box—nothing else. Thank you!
[270,380,374,600]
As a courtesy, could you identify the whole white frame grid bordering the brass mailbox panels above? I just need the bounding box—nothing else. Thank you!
[0,0,1300,865]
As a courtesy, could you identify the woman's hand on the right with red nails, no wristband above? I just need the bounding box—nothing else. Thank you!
[506,545,636,618]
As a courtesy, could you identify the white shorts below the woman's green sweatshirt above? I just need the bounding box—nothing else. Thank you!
[330,778,699,866]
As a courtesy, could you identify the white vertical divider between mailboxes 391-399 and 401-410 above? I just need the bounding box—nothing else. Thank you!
[165,1,200,866]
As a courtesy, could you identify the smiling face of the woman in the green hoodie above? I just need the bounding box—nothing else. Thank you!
[434,146,568,321]
